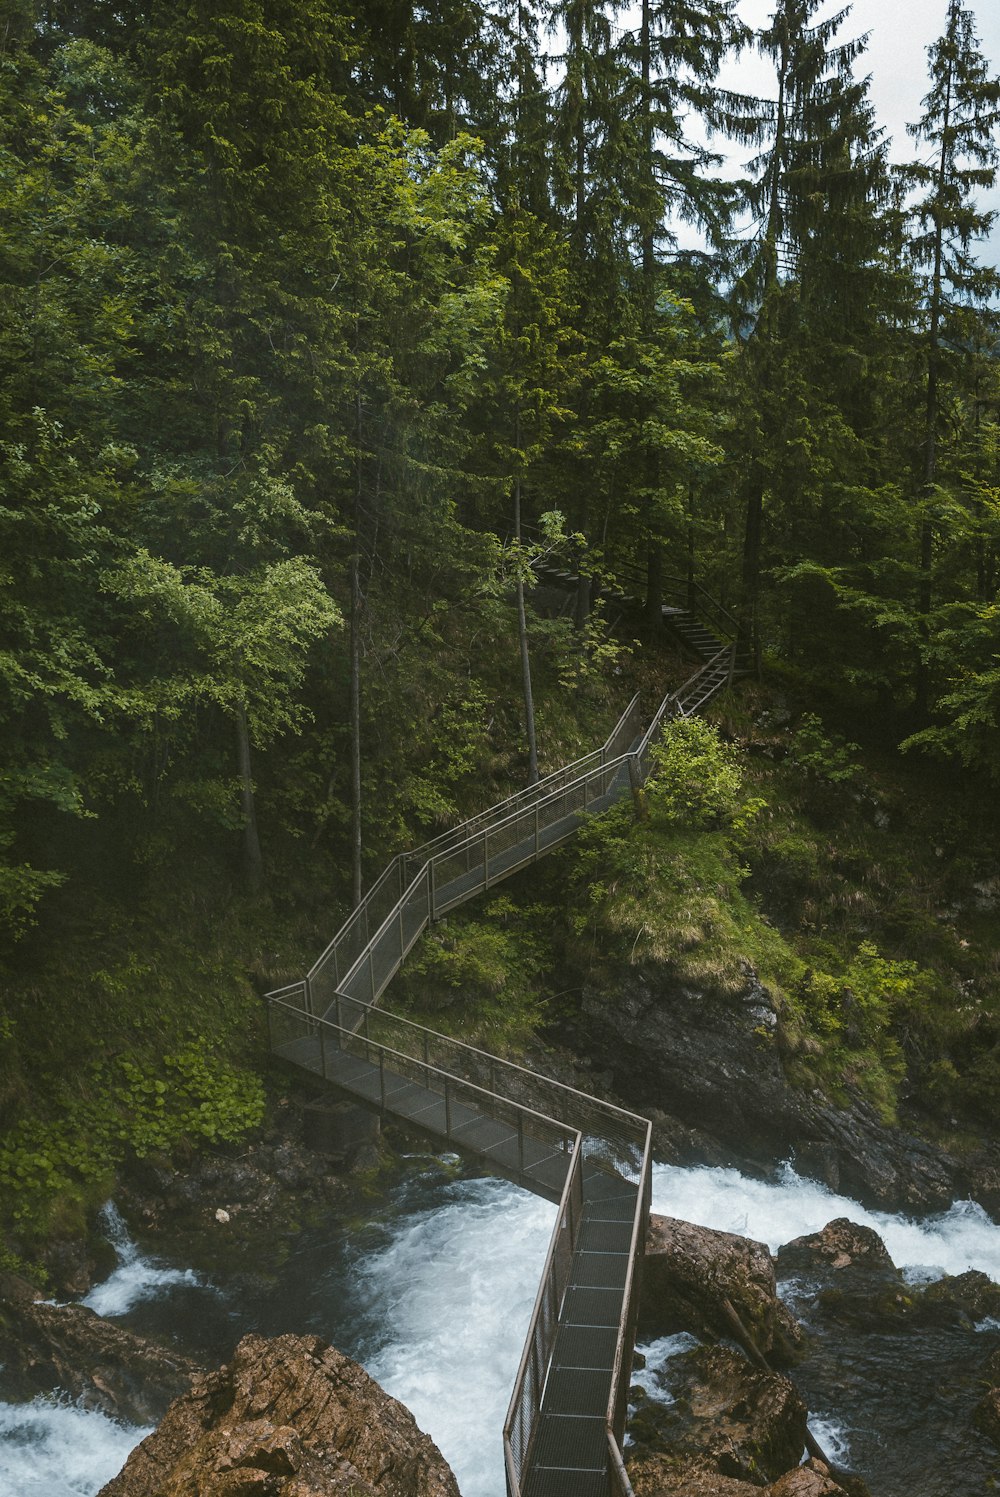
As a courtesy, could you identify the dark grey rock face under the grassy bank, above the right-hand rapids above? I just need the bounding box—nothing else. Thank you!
[566,963,964,1211]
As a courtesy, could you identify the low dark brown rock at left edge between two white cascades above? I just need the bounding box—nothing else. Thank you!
[0,1274,198,1425]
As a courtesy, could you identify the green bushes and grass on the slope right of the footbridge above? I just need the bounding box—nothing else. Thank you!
[564,695,1000,1129]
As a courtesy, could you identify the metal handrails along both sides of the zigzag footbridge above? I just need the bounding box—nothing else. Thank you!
[266,598,732,1497]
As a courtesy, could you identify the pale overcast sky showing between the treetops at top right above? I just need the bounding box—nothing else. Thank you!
[716,0,1000,265]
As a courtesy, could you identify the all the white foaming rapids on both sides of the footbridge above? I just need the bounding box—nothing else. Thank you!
[0,1162,1000,1497]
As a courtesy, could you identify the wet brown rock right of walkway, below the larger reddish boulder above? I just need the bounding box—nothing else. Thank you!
[630,1346,805,1497]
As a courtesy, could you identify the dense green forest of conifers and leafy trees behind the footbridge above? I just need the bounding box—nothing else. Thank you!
[0,0,1000,1263]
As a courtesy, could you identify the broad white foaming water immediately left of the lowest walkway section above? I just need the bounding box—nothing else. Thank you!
[359,1180,555,1497]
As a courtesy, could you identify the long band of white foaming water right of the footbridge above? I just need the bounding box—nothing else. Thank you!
[653,1165,1000,1281]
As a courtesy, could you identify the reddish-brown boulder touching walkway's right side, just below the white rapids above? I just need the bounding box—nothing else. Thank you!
[641,1216,801,1362]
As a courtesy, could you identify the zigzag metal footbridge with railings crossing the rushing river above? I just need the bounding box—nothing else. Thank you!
[266,601,734,1497]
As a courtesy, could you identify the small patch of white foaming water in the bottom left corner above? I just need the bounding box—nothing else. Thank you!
[0,1398,150,1497]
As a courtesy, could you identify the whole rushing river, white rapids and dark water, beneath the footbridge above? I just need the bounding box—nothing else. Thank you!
[0,1157,1000,1497]
